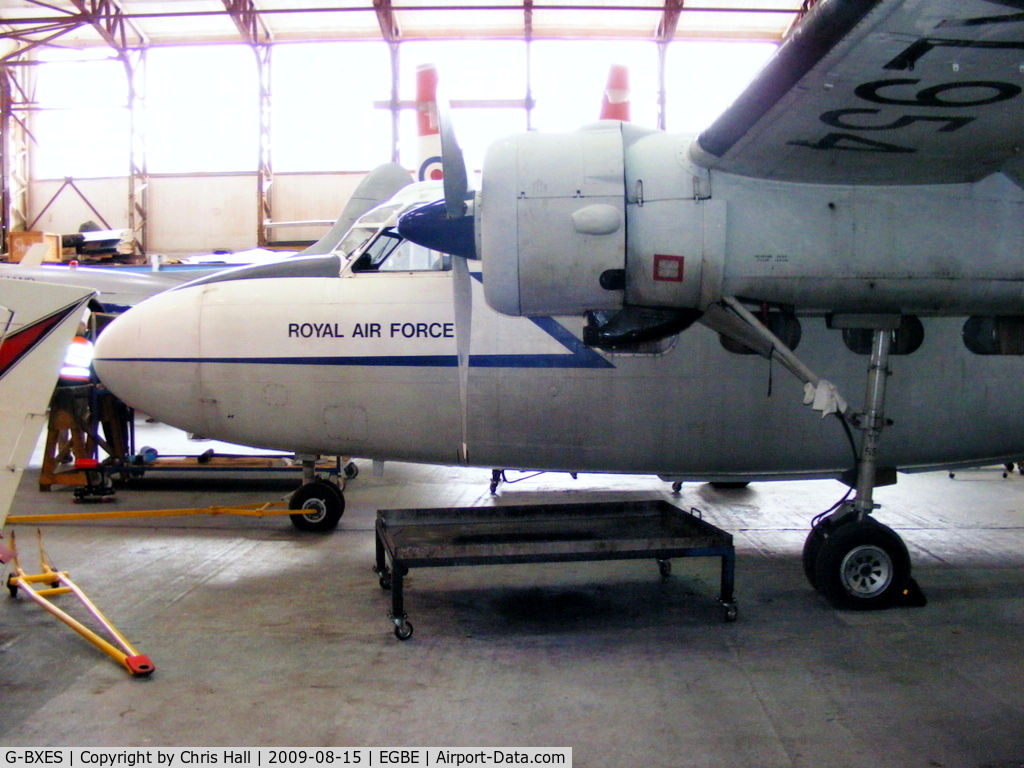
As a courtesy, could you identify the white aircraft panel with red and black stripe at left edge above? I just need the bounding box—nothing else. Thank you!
[0,278,94,527]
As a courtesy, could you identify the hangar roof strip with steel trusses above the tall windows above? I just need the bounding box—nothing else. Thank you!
[0,0,814,57]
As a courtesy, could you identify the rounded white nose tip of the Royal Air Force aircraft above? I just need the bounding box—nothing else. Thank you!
[93,288,203,432]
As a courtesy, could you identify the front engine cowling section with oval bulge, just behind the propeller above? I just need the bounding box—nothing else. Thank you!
[474,122,626,315]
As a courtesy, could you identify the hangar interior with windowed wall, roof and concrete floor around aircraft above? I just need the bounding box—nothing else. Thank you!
[0,0,1024,768]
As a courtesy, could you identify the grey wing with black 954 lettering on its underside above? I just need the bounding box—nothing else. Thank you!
[690,0,1024,185]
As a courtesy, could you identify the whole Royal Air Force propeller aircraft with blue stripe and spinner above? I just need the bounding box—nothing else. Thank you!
[96,0,1024,608]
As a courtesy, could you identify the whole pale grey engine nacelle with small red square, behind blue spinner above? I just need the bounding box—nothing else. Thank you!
[475,121,725,346]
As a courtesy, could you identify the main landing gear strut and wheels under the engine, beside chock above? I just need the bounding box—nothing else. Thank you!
[803,318,926,610]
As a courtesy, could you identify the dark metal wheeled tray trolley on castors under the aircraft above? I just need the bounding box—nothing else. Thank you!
[374,500,736,640]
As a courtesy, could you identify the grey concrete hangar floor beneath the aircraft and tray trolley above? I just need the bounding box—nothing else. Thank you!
[0,452,1024,768]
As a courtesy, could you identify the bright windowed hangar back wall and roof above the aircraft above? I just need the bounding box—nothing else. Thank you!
[0,0,809,258]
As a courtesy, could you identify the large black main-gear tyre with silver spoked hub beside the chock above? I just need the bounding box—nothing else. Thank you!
[815,517,910,610]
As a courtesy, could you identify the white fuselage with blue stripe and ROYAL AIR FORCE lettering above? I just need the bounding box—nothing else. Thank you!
[96,246,1024,478]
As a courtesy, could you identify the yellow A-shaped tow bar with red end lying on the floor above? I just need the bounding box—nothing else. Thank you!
[7,531,157,677]
